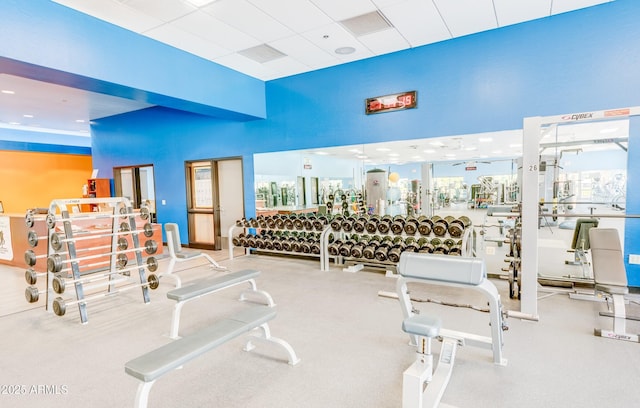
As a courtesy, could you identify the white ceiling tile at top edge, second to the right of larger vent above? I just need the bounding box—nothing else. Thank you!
[433,0,498,37]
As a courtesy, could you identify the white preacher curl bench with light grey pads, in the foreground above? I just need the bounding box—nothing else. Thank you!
[396,252,507,408]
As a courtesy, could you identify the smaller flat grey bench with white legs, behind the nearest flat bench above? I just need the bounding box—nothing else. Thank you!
[167,269,275,339]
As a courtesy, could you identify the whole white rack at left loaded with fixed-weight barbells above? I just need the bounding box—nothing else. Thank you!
[25,197,159,324]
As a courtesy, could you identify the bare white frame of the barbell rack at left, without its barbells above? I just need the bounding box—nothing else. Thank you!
[27,197,156,324]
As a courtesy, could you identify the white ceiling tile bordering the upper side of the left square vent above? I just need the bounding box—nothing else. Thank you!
[202,0,293,43]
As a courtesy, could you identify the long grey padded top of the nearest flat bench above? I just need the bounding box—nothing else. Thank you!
[124,306,276,382]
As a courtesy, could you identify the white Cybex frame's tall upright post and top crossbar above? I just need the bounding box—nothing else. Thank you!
[520,106,640,320]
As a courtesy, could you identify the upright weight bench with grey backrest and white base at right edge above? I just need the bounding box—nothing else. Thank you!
[589,228,640,343]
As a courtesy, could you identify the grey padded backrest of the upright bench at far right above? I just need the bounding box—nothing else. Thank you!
[589,228,627,286]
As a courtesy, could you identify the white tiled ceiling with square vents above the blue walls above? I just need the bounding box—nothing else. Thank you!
[53,0,609,80]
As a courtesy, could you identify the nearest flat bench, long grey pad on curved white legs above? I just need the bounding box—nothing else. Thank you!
[124,306,300,408]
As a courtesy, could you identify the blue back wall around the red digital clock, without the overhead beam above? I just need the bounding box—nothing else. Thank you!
[92,0,640,284]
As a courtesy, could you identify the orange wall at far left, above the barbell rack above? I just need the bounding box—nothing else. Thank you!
[0,150,92,213]
